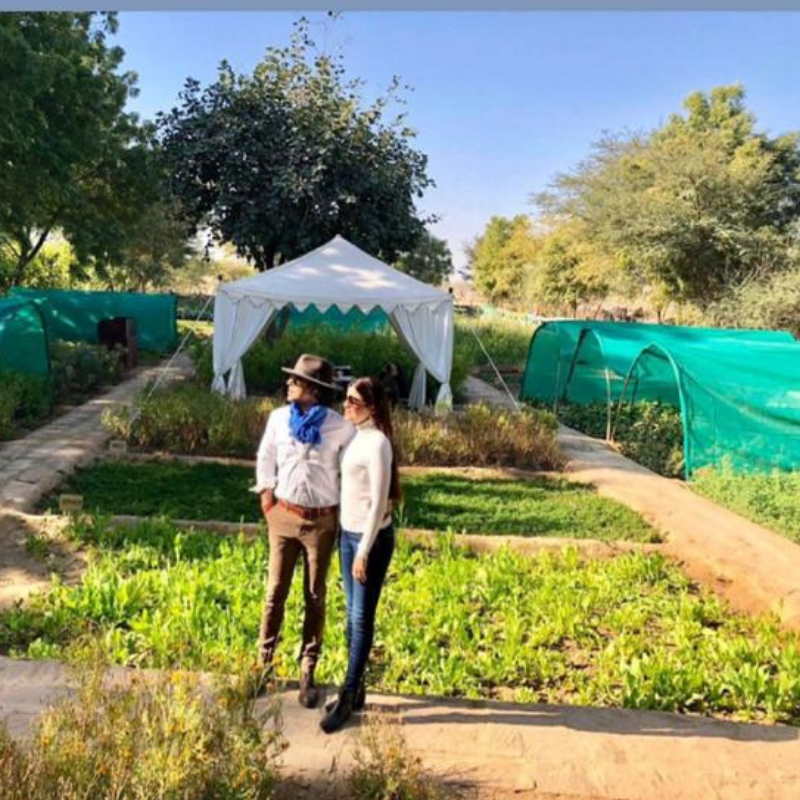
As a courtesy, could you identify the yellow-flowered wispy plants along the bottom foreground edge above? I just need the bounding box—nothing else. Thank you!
[0,664,444,800]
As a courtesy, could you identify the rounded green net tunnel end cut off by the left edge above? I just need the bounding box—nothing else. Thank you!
[0,298,50,376]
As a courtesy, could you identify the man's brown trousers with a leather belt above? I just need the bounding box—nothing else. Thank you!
[258,506,336,672]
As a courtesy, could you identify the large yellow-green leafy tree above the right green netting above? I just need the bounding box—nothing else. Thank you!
[535,86,800,305]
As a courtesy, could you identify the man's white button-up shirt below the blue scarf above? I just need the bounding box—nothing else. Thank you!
[254,406,356,508]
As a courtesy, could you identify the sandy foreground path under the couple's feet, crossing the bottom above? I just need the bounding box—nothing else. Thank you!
[0,658,800,800]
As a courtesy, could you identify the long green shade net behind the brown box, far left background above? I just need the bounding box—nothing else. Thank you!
[11,288,178,353]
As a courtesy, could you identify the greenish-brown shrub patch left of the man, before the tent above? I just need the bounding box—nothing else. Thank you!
[103,384,275,458]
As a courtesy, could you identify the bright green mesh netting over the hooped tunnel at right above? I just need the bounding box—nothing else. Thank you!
[520,320,800,476]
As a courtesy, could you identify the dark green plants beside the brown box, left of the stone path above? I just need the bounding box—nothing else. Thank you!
[50,340,124,403]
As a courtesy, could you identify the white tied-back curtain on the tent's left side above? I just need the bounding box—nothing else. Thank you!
[211,292,278,399]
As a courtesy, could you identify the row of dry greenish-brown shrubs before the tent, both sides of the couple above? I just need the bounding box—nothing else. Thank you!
[103,384,564,470]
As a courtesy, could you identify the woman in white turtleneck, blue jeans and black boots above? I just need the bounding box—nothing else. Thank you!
[321,378,400,733]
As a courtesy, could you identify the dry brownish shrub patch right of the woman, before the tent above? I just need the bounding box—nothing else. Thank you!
[395,405,564,470]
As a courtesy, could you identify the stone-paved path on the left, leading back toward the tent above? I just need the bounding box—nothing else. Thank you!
[0,356,192,608]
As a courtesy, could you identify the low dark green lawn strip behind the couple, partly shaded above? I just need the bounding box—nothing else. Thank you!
[45,461,658,541]
